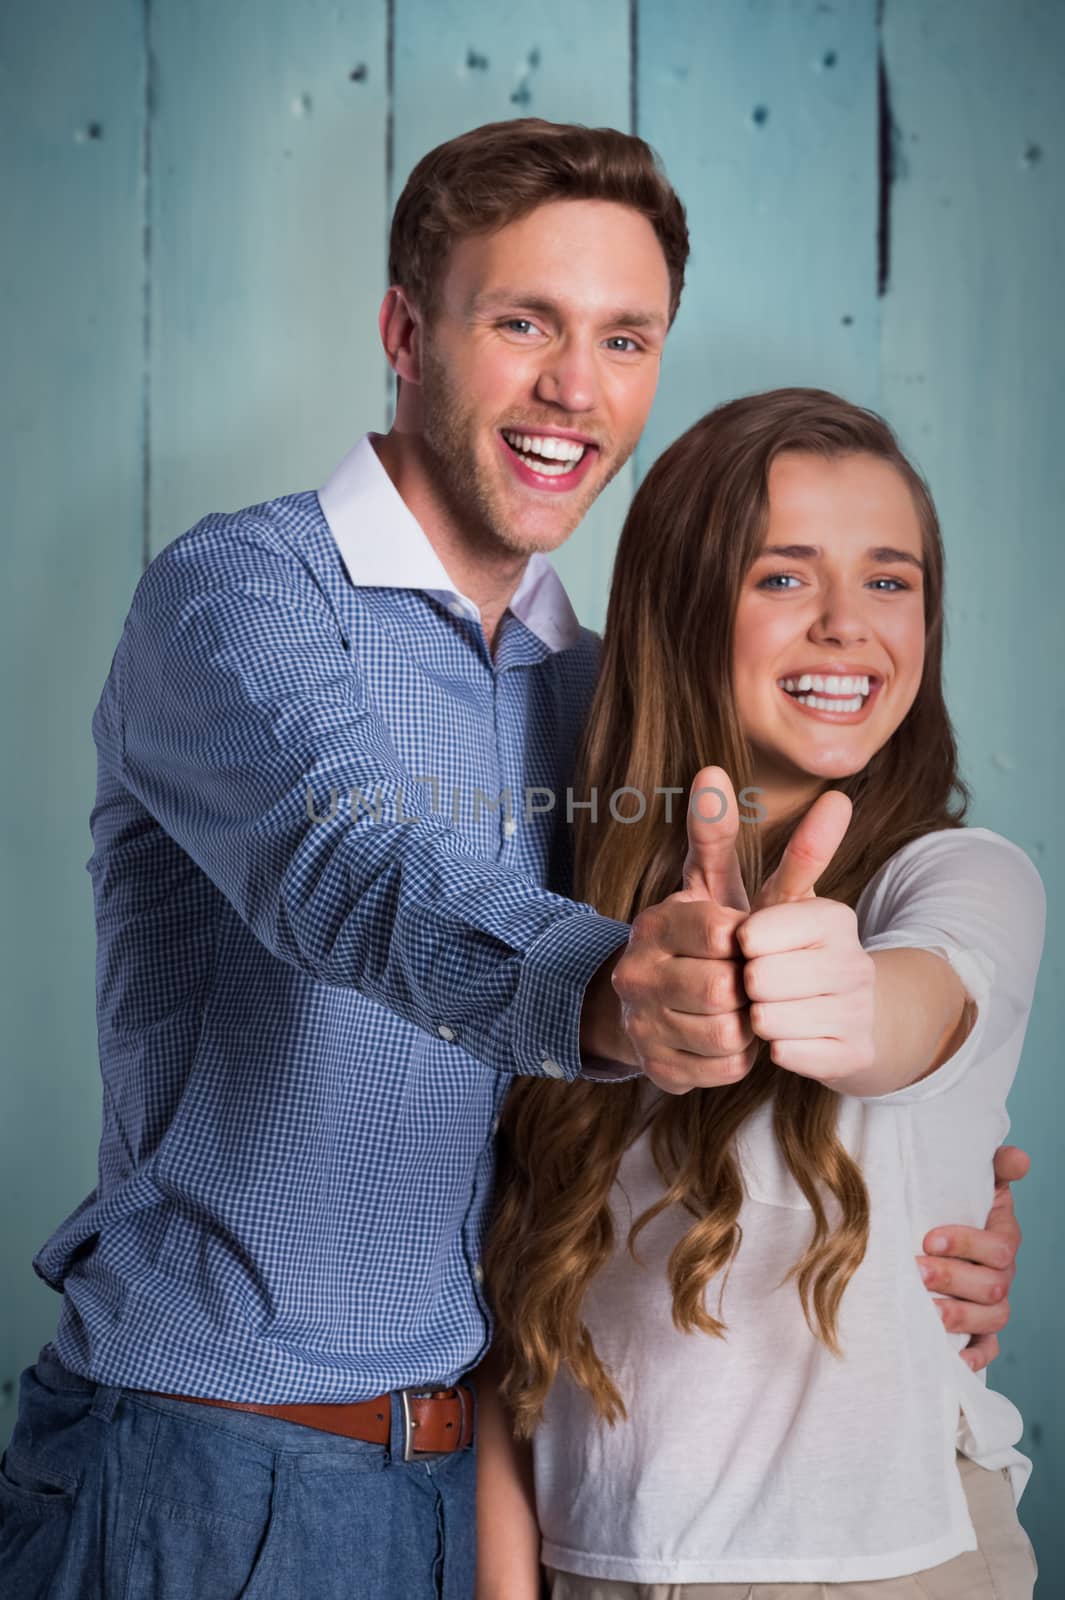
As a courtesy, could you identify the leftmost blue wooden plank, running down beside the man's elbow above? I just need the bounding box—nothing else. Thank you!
[0,0,144,1438]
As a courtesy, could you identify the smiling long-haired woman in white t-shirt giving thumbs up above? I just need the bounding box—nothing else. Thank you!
[480,389,1044,1600]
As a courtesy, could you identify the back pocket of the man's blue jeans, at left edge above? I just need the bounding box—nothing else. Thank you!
[0,1448,78,1600]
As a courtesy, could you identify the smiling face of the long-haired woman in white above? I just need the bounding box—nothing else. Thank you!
[732,451,924,821]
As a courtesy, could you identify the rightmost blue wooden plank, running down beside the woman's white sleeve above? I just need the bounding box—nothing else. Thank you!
[883,0,1065,1574]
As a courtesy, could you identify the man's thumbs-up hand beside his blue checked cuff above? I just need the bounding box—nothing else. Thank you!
[588,766,756,1094]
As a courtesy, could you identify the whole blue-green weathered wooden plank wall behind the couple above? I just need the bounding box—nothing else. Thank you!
[0,0,1065,1600]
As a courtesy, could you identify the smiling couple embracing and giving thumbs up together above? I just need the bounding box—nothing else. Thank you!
[0,120,1041,1600]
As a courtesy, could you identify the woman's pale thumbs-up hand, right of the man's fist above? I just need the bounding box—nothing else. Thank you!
[737,789,876,1093]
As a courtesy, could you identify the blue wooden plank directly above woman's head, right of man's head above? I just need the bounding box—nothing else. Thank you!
[636,0,878,470]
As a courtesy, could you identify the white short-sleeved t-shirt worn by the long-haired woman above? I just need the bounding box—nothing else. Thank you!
[534,827,1046,1584]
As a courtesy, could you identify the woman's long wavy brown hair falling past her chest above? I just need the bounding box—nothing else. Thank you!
[486,389,967,1435]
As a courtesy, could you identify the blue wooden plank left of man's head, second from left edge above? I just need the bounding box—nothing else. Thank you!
[150,0,385,550]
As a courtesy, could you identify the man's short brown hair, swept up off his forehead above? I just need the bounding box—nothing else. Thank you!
[389,117,688,323]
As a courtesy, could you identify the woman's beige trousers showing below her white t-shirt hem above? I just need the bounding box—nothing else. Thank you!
[547,1454,1038,1600]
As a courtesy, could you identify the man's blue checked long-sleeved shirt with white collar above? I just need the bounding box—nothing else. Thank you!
[35,437,628,1402]
